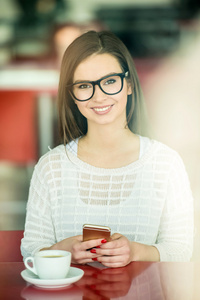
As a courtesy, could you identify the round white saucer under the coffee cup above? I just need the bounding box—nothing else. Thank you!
[21,267,84,289]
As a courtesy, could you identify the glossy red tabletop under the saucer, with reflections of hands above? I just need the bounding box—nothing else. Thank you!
[0,262,200,300]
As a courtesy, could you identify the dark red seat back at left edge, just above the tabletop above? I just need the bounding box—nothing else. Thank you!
[0,230,23,262]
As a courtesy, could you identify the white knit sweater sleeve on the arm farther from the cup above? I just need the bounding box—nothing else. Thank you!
[154,154,194,261]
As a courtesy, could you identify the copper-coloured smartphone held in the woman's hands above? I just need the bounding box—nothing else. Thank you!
[83,224,111,242]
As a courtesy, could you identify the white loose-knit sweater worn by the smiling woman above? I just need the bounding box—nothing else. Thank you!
[21,137,193,261]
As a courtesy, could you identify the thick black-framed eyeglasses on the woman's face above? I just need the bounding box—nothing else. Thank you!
[68,71,128,101]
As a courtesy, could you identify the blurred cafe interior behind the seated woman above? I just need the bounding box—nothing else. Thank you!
[0,0,200,261]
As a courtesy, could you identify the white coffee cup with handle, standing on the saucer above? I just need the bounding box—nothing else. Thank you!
[24,250,71,279]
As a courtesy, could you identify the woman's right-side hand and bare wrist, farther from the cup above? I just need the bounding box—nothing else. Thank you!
[93,233,160,268]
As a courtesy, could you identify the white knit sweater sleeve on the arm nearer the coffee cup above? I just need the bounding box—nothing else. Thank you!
[21,159,56,259]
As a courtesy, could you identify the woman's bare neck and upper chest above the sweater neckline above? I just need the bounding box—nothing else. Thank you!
[78,123,140,168]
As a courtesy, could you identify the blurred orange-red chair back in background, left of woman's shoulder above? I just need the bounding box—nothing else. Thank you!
[0,90,38,165]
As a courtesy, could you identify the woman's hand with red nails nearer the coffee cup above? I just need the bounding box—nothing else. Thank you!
[45,235,102,264]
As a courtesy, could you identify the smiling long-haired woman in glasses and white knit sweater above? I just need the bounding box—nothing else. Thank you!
[21,31,193,267]
